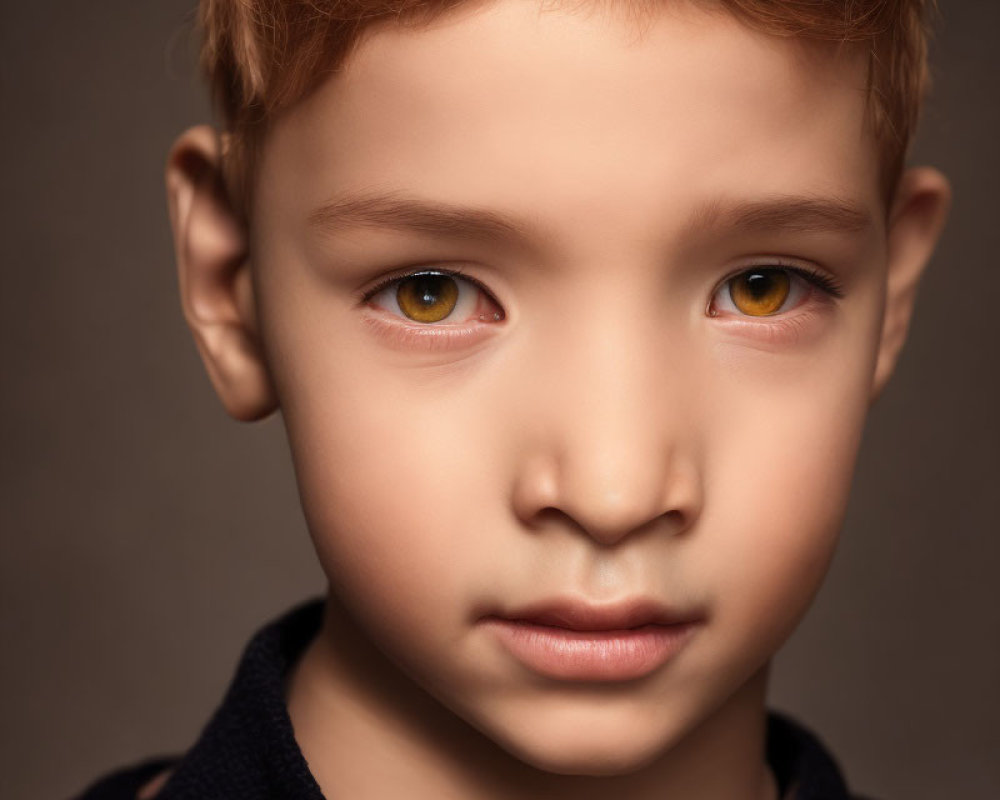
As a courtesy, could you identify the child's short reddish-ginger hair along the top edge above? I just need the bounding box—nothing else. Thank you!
[199,0,934,217]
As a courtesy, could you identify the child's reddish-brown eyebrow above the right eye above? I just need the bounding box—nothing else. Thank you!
[690,196,874,234]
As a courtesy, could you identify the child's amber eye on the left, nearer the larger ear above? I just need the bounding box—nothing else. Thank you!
[365,270,503,325]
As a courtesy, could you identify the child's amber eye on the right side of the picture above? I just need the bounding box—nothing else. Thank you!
[709,267,838,317]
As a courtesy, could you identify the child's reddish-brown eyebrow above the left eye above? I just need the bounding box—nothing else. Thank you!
[309,194,527,241]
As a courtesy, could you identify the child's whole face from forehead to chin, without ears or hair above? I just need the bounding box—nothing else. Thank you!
[213,2,928,773]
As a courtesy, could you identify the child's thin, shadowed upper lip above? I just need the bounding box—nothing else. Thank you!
[494,598,700,631]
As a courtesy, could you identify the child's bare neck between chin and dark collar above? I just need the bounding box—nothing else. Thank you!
[288,592,777,800]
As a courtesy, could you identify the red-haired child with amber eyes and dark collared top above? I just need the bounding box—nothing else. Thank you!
[76,0,948,800]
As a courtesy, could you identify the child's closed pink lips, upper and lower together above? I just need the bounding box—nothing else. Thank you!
[482,601,703,681]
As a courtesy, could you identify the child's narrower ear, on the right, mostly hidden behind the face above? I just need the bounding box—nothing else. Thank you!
[871,167,951,402]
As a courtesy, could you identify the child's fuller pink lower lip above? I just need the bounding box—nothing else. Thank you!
[484,618,697,681]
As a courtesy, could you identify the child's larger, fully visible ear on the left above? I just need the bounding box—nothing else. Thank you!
[166,126,277,421]
